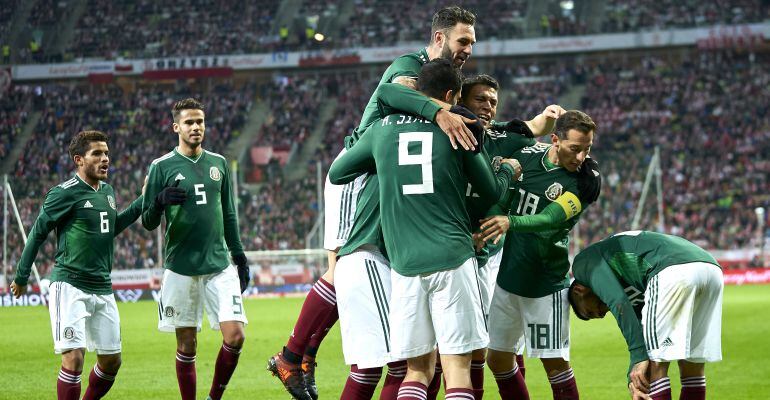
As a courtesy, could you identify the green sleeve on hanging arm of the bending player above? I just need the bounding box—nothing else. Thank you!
[572,250,648,375]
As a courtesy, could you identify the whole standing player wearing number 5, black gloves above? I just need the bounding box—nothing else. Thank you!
[142,99,249,400]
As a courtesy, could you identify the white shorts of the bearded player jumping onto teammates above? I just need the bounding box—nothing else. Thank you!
[324,149,366,251]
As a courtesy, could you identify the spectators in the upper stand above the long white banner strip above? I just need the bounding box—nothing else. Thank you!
[0,0,770,62]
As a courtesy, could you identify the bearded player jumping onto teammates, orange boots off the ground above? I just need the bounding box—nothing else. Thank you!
[268,7,476,399]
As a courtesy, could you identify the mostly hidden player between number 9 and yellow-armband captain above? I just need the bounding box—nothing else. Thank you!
[456,74,565,399]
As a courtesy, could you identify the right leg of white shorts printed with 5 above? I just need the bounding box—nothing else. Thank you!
[203,265,248,329]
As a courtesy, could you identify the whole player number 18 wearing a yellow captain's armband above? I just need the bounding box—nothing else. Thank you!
[481,110,599,400]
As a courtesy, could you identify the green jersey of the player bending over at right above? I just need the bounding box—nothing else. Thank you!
[572,231,719,371]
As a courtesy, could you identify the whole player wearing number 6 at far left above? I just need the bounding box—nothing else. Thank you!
[11,131,142,400]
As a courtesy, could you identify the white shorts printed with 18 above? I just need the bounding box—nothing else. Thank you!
[489,285,569,361]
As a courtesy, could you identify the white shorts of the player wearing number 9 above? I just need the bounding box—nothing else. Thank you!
[390,257,489,360]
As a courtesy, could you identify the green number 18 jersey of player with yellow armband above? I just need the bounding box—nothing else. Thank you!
[497,143,582,298]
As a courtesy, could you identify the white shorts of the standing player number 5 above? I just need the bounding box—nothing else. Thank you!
[158,265,248,332]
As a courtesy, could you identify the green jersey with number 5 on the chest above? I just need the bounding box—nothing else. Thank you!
[142,149,243,276]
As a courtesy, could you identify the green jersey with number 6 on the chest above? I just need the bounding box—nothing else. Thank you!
[14,175,142,294]
